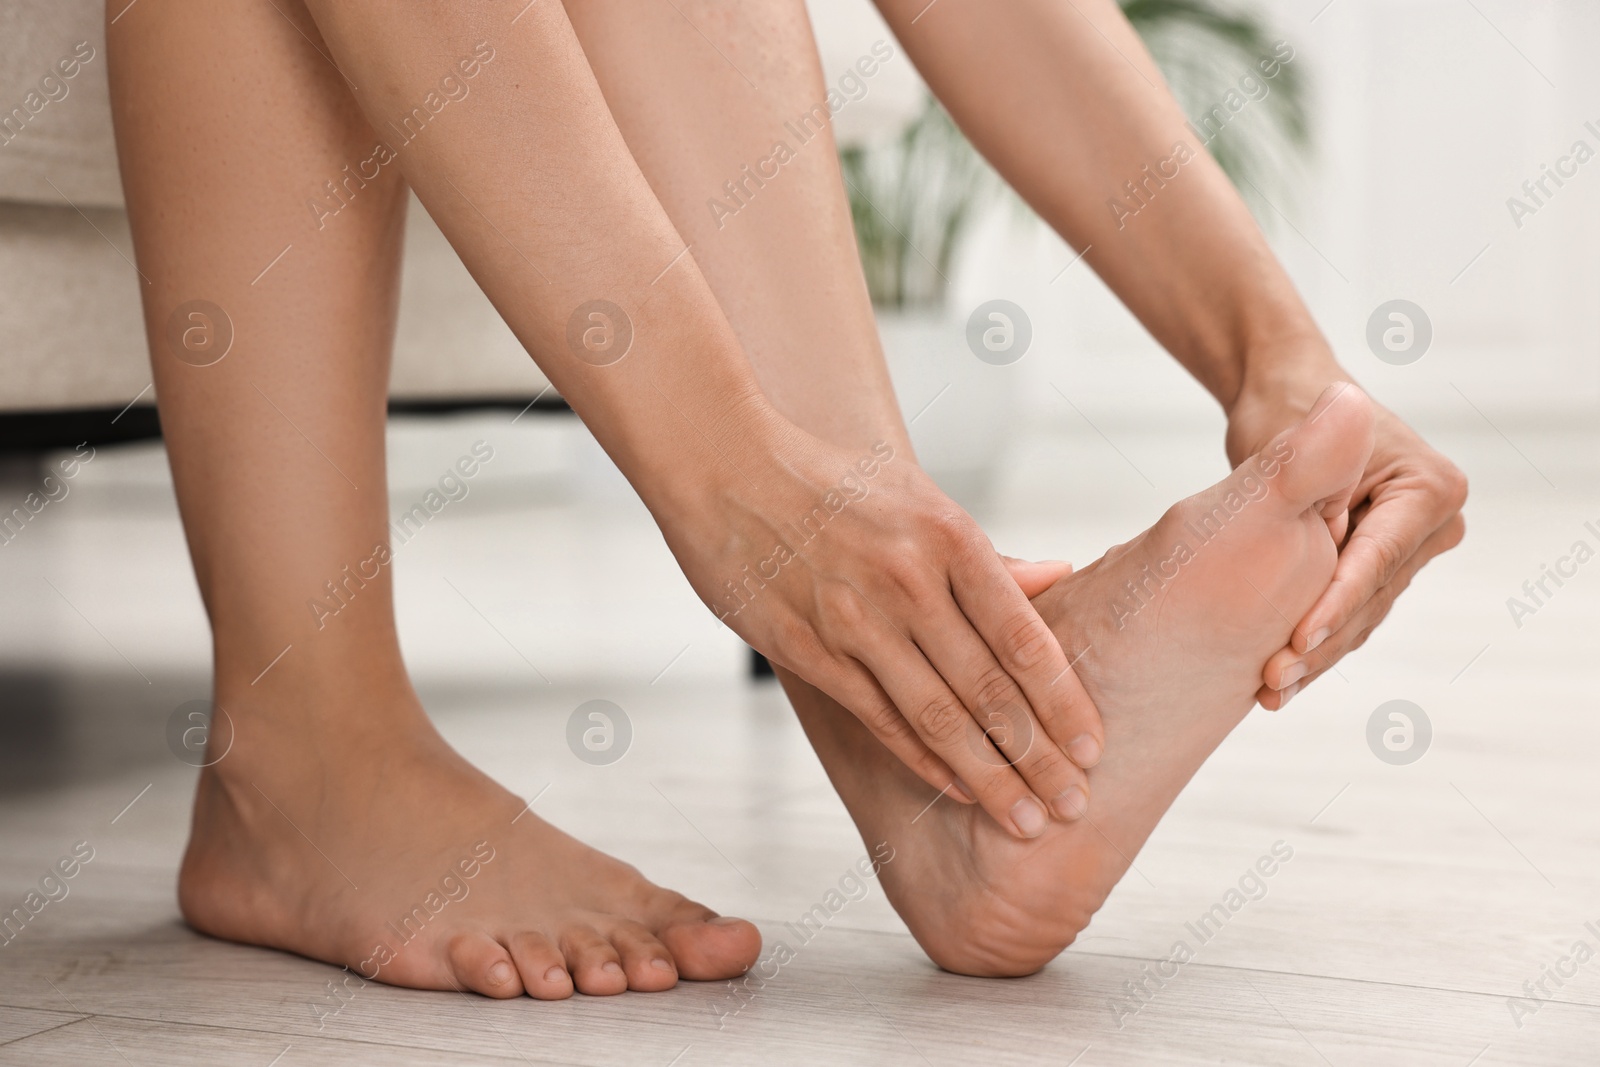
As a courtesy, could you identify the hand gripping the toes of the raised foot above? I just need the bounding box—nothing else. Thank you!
[1227,370,1467,712]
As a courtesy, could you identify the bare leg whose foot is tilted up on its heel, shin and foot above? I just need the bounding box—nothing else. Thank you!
[568,0,1371,974]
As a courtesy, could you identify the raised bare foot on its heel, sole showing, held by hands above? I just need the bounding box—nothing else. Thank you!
[786,387,1373,976]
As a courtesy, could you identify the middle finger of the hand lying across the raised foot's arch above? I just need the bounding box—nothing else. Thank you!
[910,605,1090,822]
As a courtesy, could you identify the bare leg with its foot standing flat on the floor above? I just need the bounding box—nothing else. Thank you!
[109,0,758,998]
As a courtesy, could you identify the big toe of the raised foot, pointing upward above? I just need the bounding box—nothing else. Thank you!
[1246,382,1373,518]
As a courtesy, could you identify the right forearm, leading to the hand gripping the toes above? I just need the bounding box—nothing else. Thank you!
[878,0,1338,408]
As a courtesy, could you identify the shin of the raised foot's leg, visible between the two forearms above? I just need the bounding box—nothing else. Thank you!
[566,0,912,456]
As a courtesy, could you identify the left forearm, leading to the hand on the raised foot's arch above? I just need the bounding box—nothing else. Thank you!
[310,0,781,499]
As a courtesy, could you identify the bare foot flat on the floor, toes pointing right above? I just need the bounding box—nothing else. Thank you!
[178,693,762,1000]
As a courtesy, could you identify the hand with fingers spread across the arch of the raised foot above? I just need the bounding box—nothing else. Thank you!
[658,427,1104,838]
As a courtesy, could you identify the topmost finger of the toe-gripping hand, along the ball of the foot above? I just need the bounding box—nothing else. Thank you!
[1291,493,1450,653]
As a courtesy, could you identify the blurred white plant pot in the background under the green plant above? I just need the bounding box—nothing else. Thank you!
[877,307,1021,510]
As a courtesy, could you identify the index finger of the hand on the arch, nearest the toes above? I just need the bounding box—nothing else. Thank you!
[950,541,1106,768]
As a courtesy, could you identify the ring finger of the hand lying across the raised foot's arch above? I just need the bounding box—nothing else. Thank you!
[856,625,1050,838]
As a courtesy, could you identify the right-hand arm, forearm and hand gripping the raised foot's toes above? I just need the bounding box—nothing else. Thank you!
[877,0,1467,710]
